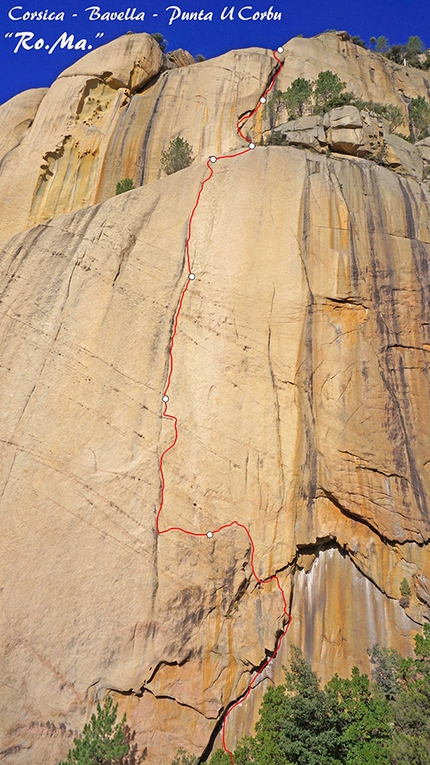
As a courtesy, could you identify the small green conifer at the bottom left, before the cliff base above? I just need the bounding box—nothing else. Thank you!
[60,696,130,765]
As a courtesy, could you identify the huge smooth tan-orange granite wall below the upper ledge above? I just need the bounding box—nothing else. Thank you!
[0,32,430,765]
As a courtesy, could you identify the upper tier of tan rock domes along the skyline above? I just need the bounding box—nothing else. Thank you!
[0,32,429,239]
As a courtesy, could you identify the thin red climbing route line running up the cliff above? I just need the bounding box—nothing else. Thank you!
[155,49,292,765]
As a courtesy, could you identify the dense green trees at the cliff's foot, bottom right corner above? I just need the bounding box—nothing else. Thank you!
[173,628,430,765]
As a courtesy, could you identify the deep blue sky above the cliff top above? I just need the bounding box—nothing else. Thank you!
[0,0,430,103]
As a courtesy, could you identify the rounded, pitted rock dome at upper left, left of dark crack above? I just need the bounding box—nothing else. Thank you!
[0,34,194,239]
